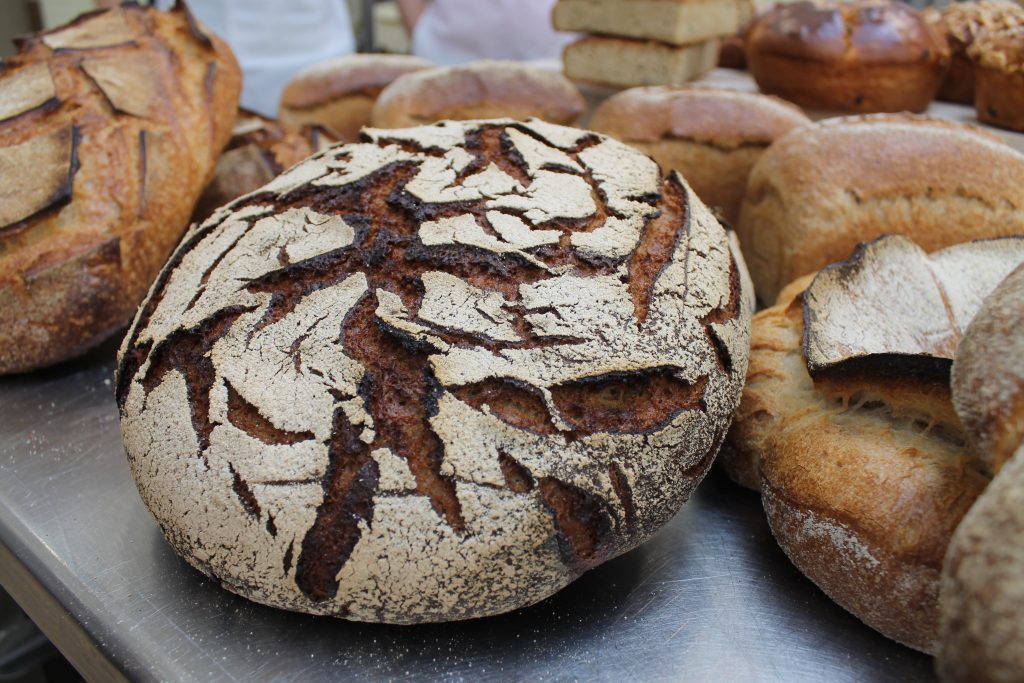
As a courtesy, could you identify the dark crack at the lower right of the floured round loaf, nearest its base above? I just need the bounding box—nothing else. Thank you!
[538,477,611,571]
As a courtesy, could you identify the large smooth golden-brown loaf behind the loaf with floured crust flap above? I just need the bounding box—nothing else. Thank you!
[736,115,1024,302]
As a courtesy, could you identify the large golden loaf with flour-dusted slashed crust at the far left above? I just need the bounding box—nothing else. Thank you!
[0,3,241,373]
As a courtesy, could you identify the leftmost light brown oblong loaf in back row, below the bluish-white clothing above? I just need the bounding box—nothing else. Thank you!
[278,54,433,143]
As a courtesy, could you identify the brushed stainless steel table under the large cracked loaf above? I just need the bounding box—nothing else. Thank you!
[0,345,933,682]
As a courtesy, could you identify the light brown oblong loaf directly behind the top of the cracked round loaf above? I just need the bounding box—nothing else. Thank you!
[370,61,585,128]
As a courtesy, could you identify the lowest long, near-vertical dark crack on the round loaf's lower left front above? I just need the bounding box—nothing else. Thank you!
[296,408,380,602]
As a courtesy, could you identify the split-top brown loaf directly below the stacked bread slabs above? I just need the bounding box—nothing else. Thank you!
[590,86,811,223]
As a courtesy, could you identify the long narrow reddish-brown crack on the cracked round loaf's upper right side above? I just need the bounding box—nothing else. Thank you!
[628,174,690,327]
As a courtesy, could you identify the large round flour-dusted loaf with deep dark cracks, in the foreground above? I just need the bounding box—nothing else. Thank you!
[117,120,753,624]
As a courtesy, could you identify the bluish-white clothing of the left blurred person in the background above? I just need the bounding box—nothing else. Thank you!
[166,0,355,118]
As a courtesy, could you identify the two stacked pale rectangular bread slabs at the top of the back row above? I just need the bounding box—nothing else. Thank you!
[553,0,754,87]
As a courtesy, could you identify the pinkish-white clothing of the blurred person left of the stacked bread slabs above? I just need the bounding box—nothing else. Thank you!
[413,0,577,65]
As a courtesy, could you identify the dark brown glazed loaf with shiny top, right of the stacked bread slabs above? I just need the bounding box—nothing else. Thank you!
[746,0,949,113]
